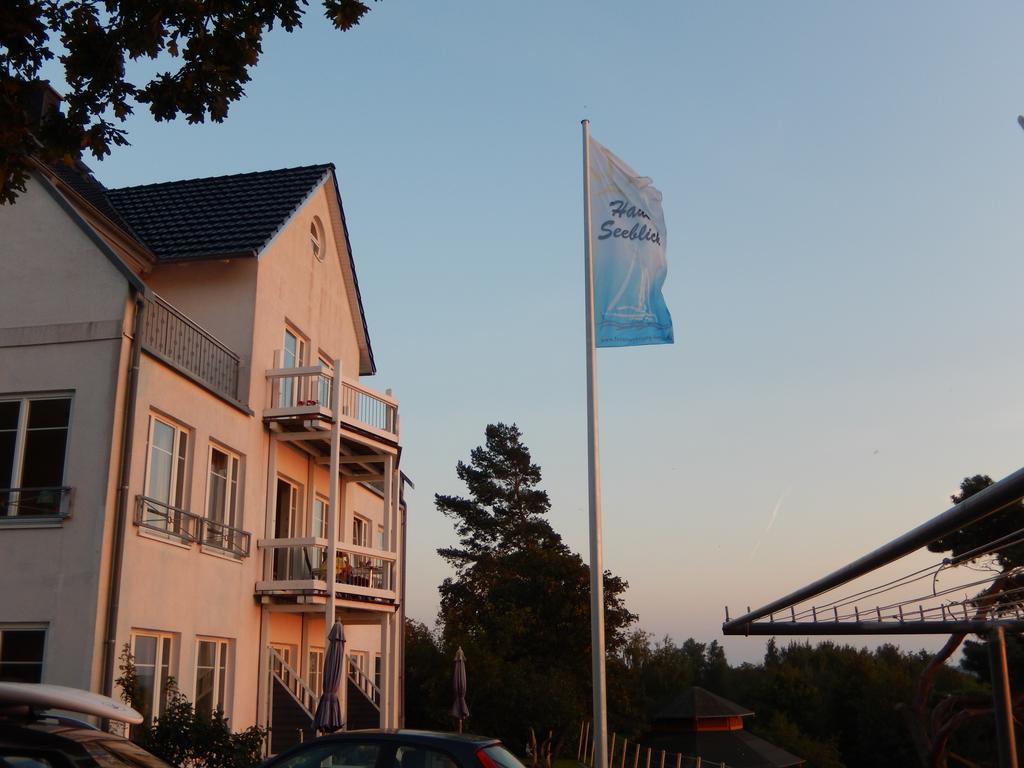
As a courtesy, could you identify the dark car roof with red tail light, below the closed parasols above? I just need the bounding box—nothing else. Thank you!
[261,730,523,768]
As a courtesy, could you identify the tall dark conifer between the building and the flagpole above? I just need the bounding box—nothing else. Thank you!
[435,424,636,754]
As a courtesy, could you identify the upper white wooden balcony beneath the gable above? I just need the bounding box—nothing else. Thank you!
[263,366,398,442]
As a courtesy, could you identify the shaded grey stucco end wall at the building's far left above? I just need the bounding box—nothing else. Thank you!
[0,174,129,688]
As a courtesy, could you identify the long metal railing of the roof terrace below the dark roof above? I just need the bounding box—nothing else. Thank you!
[140,296,240,400]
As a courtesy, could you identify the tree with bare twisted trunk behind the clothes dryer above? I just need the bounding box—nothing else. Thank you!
[907,475,1024,768]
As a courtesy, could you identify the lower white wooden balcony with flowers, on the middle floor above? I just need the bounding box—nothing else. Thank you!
[256,537,397,602]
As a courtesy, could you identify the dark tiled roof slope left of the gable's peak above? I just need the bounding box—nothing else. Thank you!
[106,165,334,261]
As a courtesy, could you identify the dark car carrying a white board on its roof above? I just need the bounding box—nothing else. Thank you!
[0,682,171,768]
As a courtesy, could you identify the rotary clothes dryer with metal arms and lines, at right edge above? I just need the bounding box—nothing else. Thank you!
[722,468,1024,768]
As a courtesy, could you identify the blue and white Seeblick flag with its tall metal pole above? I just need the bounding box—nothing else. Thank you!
[583,120,674,768]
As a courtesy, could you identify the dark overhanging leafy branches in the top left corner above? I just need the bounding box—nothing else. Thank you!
[0,0,380,203]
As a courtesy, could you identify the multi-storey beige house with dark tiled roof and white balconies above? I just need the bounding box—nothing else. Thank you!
[0,159,406,752]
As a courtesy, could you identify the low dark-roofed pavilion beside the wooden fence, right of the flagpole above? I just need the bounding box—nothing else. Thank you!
[642,686,805,768]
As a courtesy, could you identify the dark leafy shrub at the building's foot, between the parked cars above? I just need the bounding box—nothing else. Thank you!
[115,643,267,768]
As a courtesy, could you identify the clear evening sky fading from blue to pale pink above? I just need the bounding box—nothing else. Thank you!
[44,0,1024,663]
